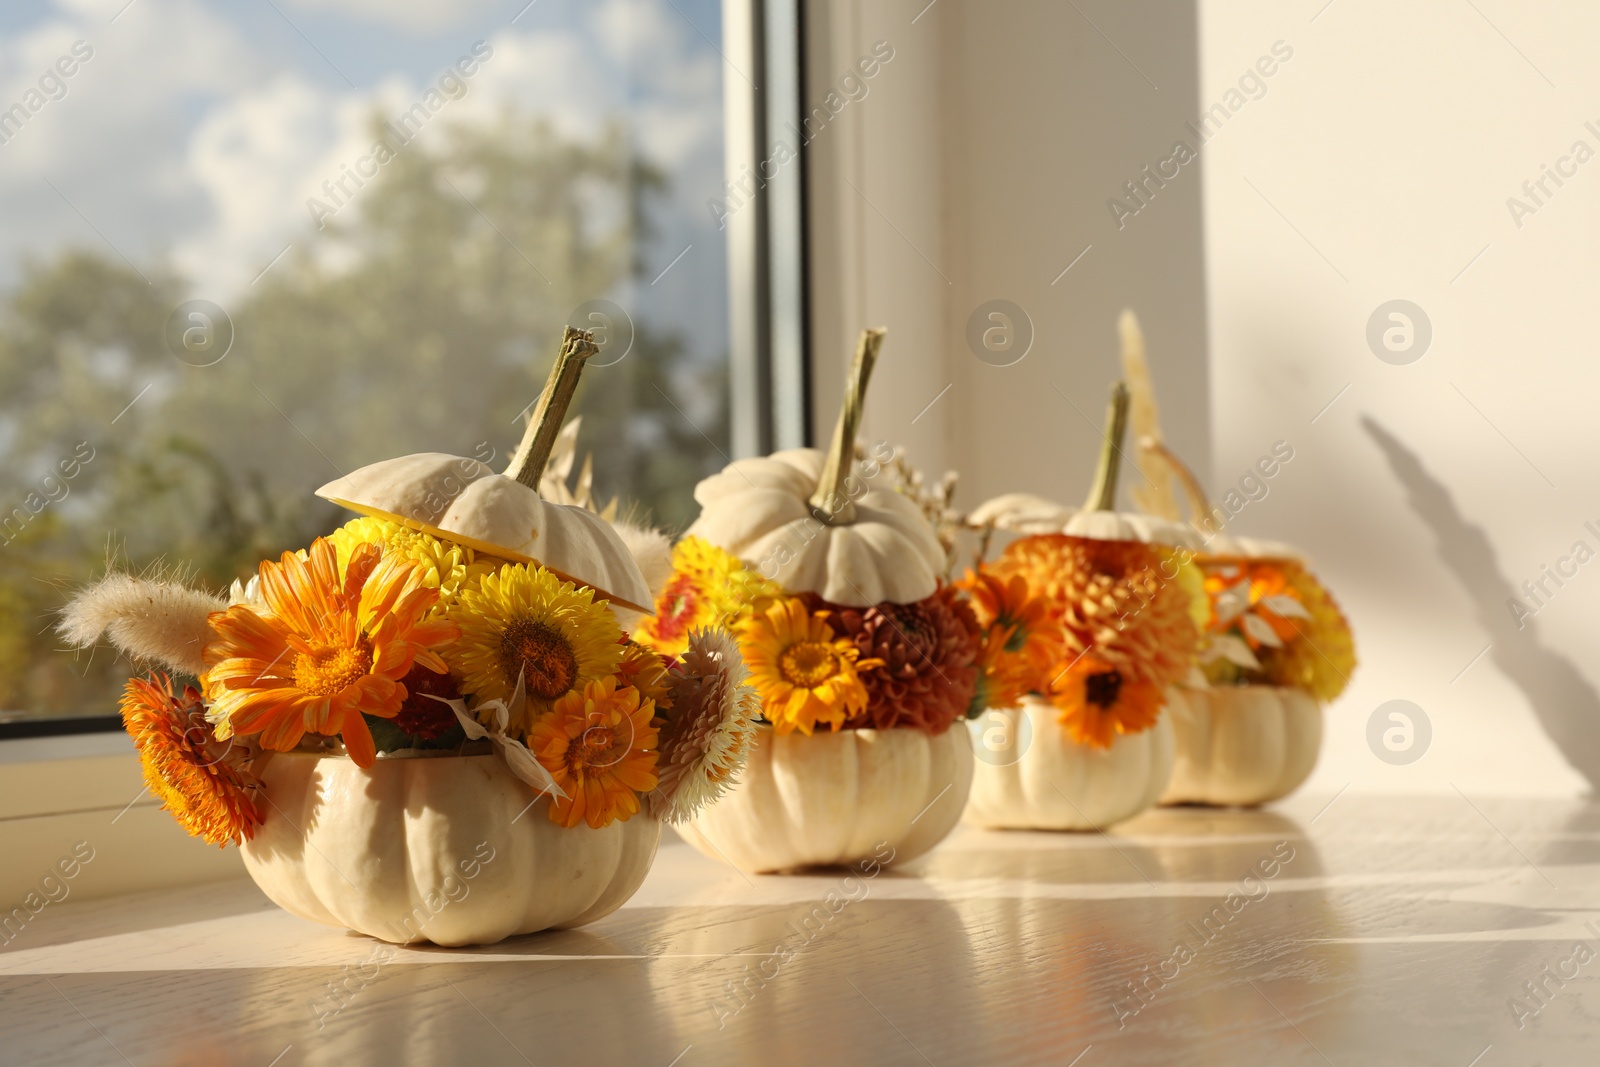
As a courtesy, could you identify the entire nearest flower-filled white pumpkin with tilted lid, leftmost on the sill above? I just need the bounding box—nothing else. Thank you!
[62,330,755,945]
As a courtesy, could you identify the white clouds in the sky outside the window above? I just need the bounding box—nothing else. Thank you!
[0,0,720,302]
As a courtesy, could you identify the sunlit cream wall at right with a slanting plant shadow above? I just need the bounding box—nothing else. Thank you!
[1200,0,1600,795]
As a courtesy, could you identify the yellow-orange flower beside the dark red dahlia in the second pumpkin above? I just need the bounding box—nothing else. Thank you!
[739,597,882,734]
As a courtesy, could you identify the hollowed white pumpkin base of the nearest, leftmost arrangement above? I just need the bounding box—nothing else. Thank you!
[240,752,661,945]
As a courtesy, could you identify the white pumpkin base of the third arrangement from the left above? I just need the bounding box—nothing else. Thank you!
[966,689,1184,830]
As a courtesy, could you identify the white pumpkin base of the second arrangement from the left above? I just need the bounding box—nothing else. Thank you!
[678,725,973,873]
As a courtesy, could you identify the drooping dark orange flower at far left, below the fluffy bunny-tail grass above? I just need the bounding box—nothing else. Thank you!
[122,673,261,848]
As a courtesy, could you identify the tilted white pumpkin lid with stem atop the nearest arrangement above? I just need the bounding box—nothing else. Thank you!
[317,326,650,613]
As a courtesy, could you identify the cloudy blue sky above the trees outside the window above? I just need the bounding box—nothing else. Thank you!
[0,0,738,358]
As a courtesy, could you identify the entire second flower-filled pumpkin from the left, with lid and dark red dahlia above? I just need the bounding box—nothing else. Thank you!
[640,330,979,872]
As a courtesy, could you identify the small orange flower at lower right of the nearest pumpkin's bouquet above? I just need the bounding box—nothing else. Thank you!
[528,675,658,830]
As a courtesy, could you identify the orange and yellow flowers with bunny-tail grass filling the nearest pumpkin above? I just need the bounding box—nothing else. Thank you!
[59,329,757,846]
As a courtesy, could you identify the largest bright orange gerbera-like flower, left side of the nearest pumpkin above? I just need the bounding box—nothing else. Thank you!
[205,537,461,766]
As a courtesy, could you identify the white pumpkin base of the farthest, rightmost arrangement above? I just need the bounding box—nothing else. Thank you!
[1162,685,1322,806]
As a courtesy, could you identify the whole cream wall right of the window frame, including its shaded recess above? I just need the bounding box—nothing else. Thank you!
[808,0,1600,795]
